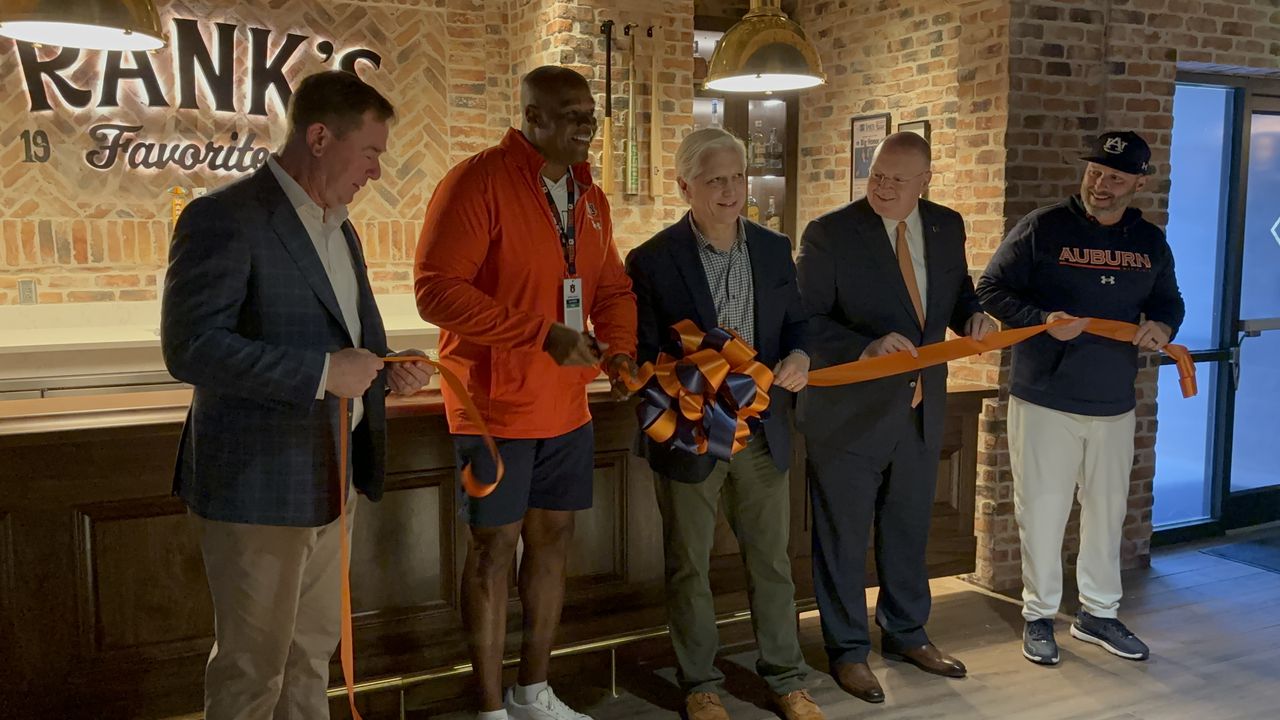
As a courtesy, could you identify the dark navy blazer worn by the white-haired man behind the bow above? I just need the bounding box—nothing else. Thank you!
[627,213,805,483]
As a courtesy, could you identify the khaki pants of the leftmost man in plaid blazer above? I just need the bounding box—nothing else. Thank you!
[192,493,356,720]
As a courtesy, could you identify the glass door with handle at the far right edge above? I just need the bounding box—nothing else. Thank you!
[1222,95,1280,528]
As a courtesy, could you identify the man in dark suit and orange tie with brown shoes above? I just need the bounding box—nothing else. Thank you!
[797,133,995,702]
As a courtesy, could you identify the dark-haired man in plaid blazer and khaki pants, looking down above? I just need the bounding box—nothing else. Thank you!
[161,72,430,720]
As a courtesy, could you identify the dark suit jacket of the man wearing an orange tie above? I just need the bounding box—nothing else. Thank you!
[797,197,980,455]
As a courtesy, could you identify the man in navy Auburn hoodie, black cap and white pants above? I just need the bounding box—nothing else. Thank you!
[978,132,1184,665]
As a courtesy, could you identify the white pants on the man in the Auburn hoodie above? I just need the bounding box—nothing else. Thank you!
[1009,397,1135,621]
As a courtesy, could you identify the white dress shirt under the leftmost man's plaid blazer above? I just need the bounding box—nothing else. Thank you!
[266,156,365,429]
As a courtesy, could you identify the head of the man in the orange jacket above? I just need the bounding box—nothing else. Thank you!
[520,65,595,170]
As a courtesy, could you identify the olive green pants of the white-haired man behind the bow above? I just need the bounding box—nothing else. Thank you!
[654,433,809,694]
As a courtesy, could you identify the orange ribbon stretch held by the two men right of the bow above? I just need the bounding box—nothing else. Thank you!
[809,318,1197,397]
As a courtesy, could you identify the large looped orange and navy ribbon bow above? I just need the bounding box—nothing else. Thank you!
[622,320,773,460]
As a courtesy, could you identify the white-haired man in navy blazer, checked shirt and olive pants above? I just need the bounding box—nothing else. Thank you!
[627,128,823,720]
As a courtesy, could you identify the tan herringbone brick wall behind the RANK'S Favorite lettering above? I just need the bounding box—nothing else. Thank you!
[0,0,483,304]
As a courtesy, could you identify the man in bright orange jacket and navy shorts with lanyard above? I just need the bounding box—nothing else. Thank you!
[413,65,636,720]
